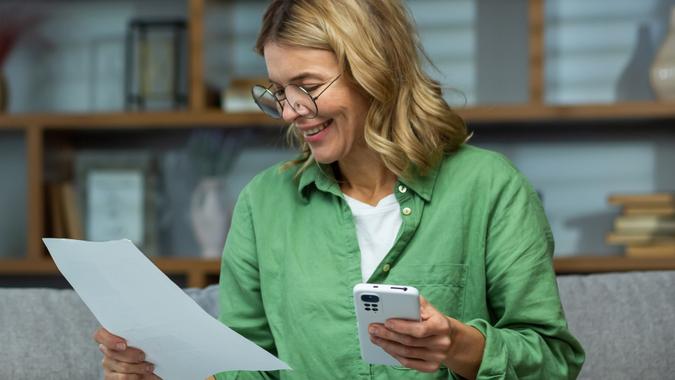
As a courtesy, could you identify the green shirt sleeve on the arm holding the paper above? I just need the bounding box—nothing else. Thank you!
[216,189,279,380]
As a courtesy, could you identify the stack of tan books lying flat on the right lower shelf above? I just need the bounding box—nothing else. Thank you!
[607,193,675,258]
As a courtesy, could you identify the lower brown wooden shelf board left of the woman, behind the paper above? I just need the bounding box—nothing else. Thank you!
[0,258,220,288]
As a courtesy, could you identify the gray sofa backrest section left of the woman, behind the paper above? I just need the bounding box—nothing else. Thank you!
[0,285,218,380]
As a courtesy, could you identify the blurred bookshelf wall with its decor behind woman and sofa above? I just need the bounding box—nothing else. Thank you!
[0,0,675,287]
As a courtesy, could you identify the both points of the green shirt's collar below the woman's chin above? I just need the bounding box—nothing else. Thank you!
[298,160,443,202]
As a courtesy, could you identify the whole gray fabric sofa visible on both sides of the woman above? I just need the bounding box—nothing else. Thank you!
[0,271,675,380]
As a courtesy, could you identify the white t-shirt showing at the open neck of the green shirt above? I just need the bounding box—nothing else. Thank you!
[344,193,403,282]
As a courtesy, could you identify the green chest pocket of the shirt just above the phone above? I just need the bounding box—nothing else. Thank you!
[387,264,467,320]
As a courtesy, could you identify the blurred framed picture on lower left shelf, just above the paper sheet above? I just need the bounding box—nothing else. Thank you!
[75,151,158,256]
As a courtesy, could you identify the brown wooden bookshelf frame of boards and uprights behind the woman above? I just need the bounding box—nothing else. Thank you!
[0,0,675,287]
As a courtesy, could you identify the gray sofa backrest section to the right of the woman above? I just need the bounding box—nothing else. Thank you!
[558,271,675,380]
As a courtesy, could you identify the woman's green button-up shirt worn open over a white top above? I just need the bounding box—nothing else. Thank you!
[217,145,584,379]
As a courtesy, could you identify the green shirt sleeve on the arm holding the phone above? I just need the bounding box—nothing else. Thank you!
[467,167,584,379]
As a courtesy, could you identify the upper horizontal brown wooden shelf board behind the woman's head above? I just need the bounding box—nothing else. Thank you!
[0,102,675,129]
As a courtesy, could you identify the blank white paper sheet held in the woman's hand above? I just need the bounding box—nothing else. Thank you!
[43,239,290,380]
